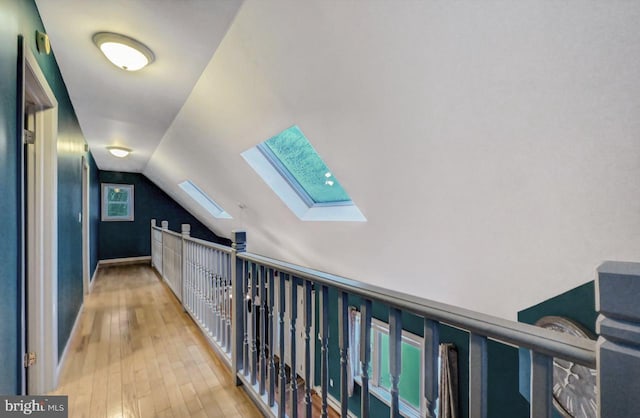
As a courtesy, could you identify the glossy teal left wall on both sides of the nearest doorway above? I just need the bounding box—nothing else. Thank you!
[0,0,91,394]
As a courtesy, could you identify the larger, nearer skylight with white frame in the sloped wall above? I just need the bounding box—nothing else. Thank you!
[242,125,366,222]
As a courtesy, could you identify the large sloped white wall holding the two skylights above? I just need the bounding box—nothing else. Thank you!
[145,0,640,318]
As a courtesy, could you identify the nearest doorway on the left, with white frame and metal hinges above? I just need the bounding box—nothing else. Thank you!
[19,40,58,394]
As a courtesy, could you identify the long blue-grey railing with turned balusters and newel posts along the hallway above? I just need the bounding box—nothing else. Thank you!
[151,221,640,418]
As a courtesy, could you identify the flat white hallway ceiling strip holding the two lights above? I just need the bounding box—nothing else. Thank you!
[36,0,242,172]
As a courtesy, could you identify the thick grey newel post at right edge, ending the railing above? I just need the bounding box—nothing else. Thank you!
[596,261,640,418]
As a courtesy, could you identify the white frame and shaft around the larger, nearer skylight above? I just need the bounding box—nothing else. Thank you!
[241,125,367,222]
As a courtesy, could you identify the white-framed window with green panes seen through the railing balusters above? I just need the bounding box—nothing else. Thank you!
[350,312,424,417]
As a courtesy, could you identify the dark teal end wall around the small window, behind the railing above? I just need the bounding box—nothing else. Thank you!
[98,171,231,260]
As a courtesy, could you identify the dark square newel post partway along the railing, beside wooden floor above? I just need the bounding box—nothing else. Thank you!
[231,230,247,385]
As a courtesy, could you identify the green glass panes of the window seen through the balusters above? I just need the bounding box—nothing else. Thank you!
[380,333,420,409]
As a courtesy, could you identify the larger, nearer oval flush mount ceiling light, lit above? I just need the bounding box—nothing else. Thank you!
[93,32,155,71]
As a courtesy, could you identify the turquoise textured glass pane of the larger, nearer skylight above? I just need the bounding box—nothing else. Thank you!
[264,126,351,203]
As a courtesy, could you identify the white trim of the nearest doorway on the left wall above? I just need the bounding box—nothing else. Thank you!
[24,47,58,394]
